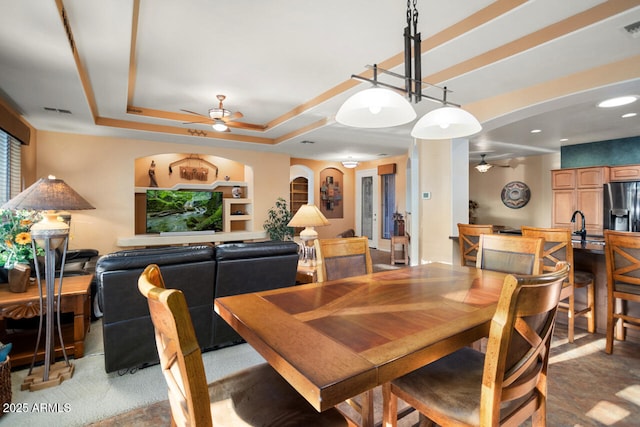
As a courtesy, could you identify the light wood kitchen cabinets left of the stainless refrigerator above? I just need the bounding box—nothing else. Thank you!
[551,166,609,235]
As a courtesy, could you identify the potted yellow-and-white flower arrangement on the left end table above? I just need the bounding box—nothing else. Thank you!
[0,209,44,292]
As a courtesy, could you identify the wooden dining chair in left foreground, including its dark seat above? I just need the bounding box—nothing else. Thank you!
[138,264,348,427]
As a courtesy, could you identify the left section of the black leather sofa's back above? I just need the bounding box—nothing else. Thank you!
[96,246,216,372]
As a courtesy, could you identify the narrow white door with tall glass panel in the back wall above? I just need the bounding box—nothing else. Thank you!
[356,169,379,248]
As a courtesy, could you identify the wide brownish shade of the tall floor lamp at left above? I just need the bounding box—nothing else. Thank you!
[2,177,95,211]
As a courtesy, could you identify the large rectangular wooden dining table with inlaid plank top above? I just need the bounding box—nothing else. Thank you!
[215,263,506,420]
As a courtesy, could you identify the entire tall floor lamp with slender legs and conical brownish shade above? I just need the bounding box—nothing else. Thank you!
[2,176,94,391]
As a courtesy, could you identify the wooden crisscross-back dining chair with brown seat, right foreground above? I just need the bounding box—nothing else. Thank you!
[383,261,569,427]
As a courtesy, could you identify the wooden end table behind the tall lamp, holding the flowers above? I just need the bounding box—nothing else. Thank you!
[0,274,93,366]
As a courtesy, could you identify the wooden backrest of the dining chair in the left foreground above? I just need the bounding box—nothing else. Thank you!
[138,264,212,426]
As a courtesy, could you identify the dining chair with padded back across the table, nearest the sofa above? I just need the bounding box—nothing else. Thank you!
[314,237,373,282]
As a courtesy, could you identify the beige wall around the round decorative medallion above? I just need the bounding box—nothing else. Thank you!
[469,153,560,228]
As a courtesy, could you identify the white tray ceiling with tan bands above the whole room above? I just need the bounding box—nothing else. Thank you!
[0,0,640,166]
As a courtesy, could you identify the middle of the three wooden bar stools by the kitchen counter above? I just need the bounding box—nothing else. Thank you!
[522,226,596,342]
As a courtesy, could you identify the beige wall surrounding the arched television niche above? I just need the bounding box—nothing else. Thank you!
[36,131,290,253]
